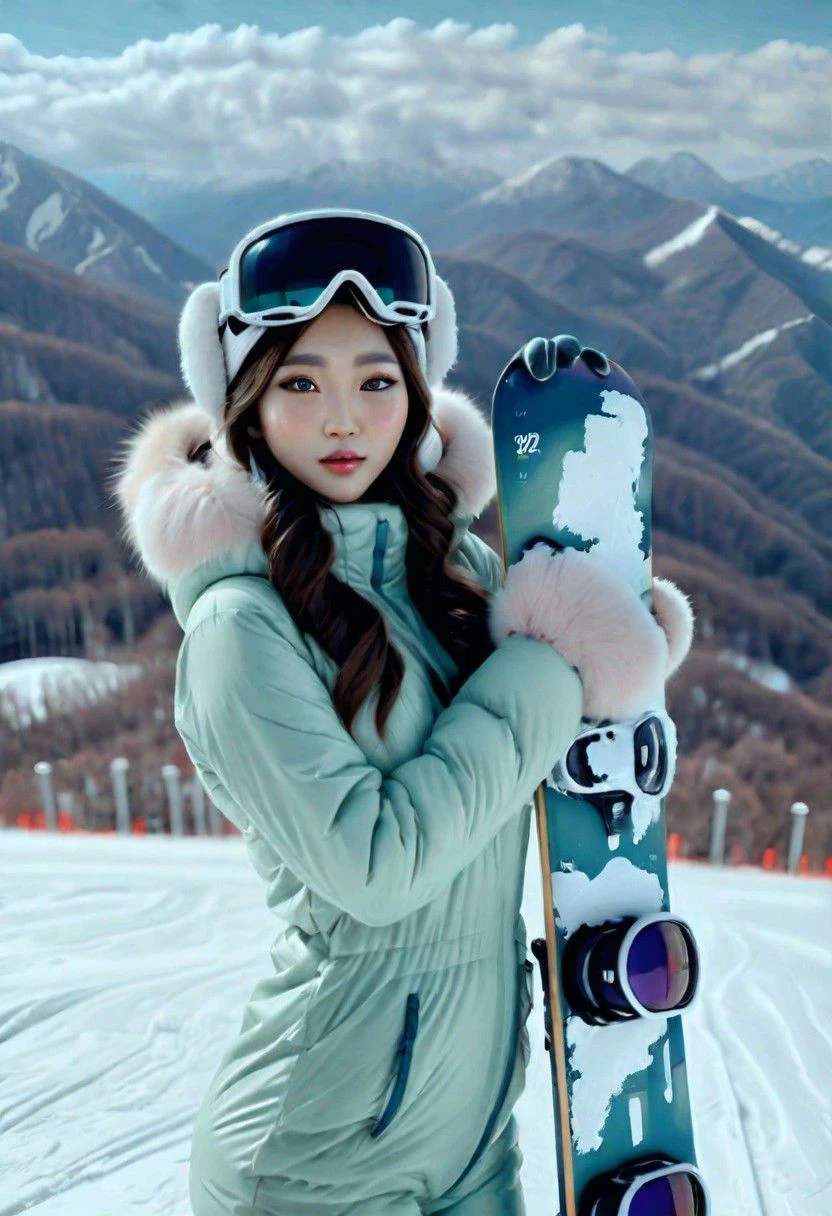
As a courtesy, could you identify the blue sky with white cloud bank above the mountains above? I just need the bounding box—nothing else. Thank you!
[0,0,832,188]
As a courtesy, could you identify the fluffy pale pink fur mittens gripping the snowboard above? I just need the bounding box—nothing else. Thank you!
[489,545,693,720]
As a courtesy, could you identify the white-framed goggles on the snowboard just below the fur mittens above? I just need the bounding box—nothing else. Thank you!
[552,711,676,832]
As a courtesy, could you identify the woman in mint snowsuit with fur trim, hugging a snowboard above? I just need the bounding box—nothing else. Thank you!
[118,209,692,1216]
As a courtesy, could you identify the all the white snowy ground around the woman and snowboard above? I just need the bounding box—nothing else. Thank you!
[0,823,832,1216]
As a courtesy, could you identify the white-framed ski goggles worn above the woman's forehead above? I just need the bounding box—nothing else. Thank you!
[218,207,435,326]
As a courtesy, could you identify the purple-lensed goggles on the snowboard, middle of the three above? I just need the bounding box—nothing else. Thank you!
[561,912,699,1026]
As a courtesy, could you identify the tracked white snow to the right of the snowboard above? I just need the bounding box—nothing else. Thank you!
[671,866,832,1216]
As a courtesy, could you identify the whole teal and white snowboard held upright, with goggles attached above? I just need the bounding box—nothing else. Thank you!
[491,334,709,1216]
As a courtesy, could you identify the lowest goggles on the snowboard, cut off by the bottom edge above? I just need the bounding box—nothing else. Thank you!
[579,1156,710,1216]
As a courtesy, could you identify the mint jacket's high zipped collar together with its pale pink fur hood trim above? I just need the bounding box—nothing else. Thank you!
[113,385,496,629]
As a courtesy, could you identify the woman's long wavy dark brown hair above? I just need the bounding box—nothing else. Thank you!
[218,283,494,738]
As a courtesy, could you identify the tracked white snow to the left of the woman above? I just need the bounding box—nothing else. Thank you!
[0,833,280,1216]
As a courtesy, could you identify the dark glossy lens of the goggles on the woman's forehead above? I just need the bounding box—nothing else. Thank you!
[233,216,428,313]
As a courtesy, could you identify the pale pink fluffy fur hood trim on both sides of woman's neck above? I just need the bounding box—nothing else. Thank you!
[113,388,496,584]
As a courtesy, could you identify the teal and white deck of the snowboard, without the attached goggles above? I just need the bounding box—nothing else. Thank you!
[491,334,696,1216]
